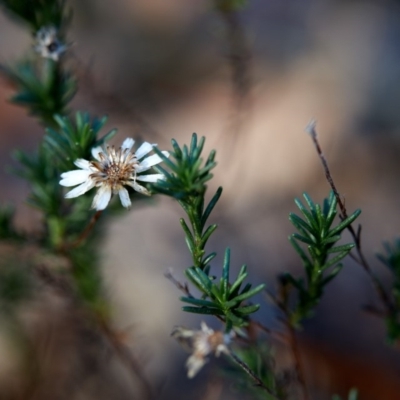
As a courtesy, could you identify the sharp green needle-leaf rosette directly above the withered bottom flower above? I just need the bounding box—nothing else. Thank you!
[181,248,265,332]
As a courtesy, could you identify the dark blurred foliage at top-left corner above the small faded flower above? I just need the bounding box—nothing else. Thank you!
[0,0,66,34]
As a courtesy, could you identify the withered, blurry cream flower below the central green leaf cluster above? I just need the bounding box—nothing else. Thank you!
[171,322,233,378]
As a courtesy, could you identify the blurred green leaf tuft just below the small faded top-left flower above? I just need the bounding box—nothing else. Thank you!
[0,59,76,126]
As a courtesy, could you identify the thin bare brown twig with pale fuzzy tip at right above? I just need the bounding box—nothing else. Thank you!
[306,120,393,314]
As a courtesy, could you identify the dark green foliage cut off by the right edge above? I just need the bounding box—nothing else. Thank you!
[377,239,400,344]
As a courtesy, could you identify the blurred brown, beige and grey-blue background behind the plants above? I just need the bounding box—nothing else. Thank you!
[0,0,400,400]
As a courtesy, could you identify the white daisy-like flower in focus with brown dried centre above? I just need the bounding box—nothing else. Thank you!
[60,138,169,211]
